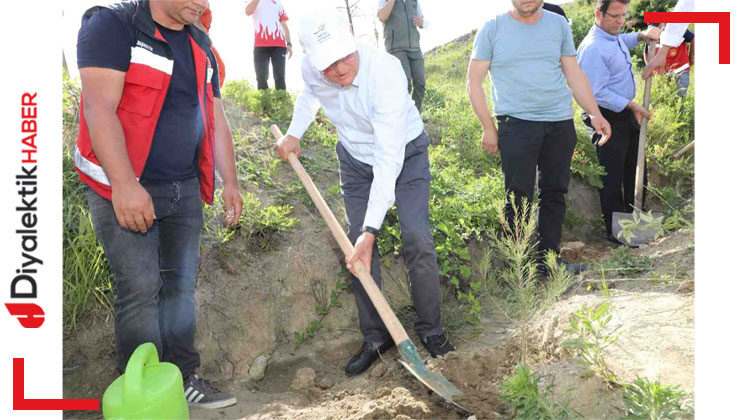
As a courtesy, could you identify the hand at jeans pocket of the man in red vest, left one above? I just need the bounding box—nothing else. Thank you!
[111,180,156,233]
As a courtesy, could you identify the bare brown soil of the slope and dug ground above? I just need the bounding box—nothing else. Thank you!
[64,101,694,420]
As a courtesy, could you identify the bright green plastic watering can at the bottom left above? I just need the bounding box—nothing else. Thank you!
[103,343,188,420]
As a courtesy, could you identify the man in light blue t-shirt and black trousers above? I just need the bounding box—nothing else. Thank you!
[468,0,611,273]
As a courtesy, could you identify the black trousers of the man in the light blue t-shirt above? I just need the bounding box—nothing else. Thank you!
[497,115,577,255]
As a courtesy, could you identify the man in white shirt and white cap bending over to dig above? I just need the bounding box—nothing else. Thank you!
[275,16,454,375]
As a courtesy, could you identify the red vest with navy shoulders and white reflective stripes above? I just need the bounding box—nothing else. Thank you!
[73,0,218,204]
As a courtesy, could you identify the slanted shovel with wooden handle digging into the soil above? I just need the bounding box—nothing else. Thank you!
[270,125,469,413]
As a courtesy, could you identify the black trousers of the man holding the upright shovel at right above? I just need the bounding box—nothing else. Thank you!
[582,107,647,238]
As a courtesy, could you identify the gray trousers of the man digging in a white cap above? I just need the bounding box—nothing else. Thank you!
[337,132,442,343]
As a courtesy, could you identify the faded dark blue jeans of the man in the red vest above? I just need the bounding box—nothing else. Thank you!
[87,178,203,378]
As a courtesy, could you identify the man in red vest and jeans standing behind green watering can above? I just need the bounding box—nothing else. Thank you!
[74,0,242,408]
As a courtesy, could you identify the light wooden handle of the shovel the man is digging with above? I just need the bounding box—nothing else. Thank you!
[270,124,409,344]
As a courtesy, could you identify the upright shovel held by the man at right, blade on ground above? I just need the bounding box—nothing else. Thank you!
[612,41,663,246]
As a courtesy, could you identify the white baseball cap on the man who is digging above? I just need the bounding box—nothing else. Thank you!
[298,12,357,70]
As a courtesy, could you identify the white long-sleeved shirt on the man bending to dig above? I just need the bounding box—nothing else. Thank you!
[287,43,424,229]
